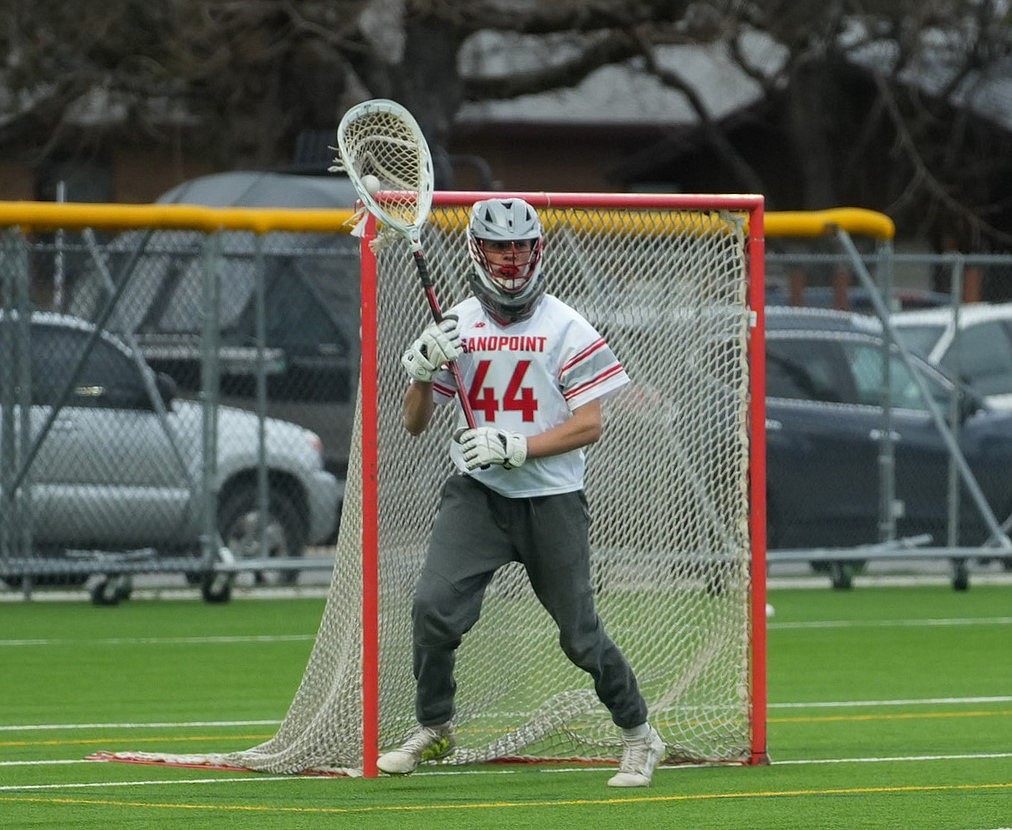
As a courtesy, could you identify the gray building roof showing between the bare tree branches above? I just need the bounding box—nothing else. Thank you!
[456,18,1012,131]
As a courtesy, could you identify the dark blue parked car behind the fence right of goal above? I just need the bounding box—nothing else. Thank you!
[766,308,1012,549]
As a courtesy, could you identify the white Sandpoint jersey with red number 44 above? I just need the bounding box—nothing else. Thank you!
[432,295,629,498]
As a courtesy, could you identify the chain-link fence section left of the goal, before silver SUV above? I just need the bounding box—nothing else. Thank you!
[0,212,359,602]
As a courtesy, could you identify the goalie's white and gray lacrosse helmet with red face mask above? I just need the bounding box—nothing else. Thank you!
[468,198,544,325]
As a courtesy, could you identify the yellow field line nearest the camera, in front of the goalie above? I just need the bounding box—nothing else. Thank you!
[0,782,1012,815]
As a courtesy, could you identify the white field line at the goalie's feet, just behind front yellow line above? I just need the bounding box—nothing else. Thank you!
[0,752,1012,793]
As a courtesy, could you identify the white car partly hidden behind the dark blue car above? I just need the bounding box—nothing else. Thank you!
[891,303,1012,410]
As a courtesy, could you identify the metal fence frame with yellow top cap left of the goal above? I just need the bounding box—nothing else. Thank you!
[0,202,353,604]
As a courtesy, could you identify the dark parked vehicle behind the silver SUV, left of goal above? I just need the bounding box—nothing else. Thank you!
[66,170,360,478]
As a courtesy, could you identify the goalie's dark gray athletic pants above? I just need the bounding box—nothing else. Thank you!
[413,476,647,728]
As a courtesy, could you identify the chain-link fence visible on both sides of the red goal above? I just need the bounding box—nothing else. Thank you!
[0,205,1012,602]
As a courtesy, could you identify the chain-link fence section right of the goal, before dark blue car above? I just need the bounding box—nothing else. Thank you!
[766,236,1012,589]
